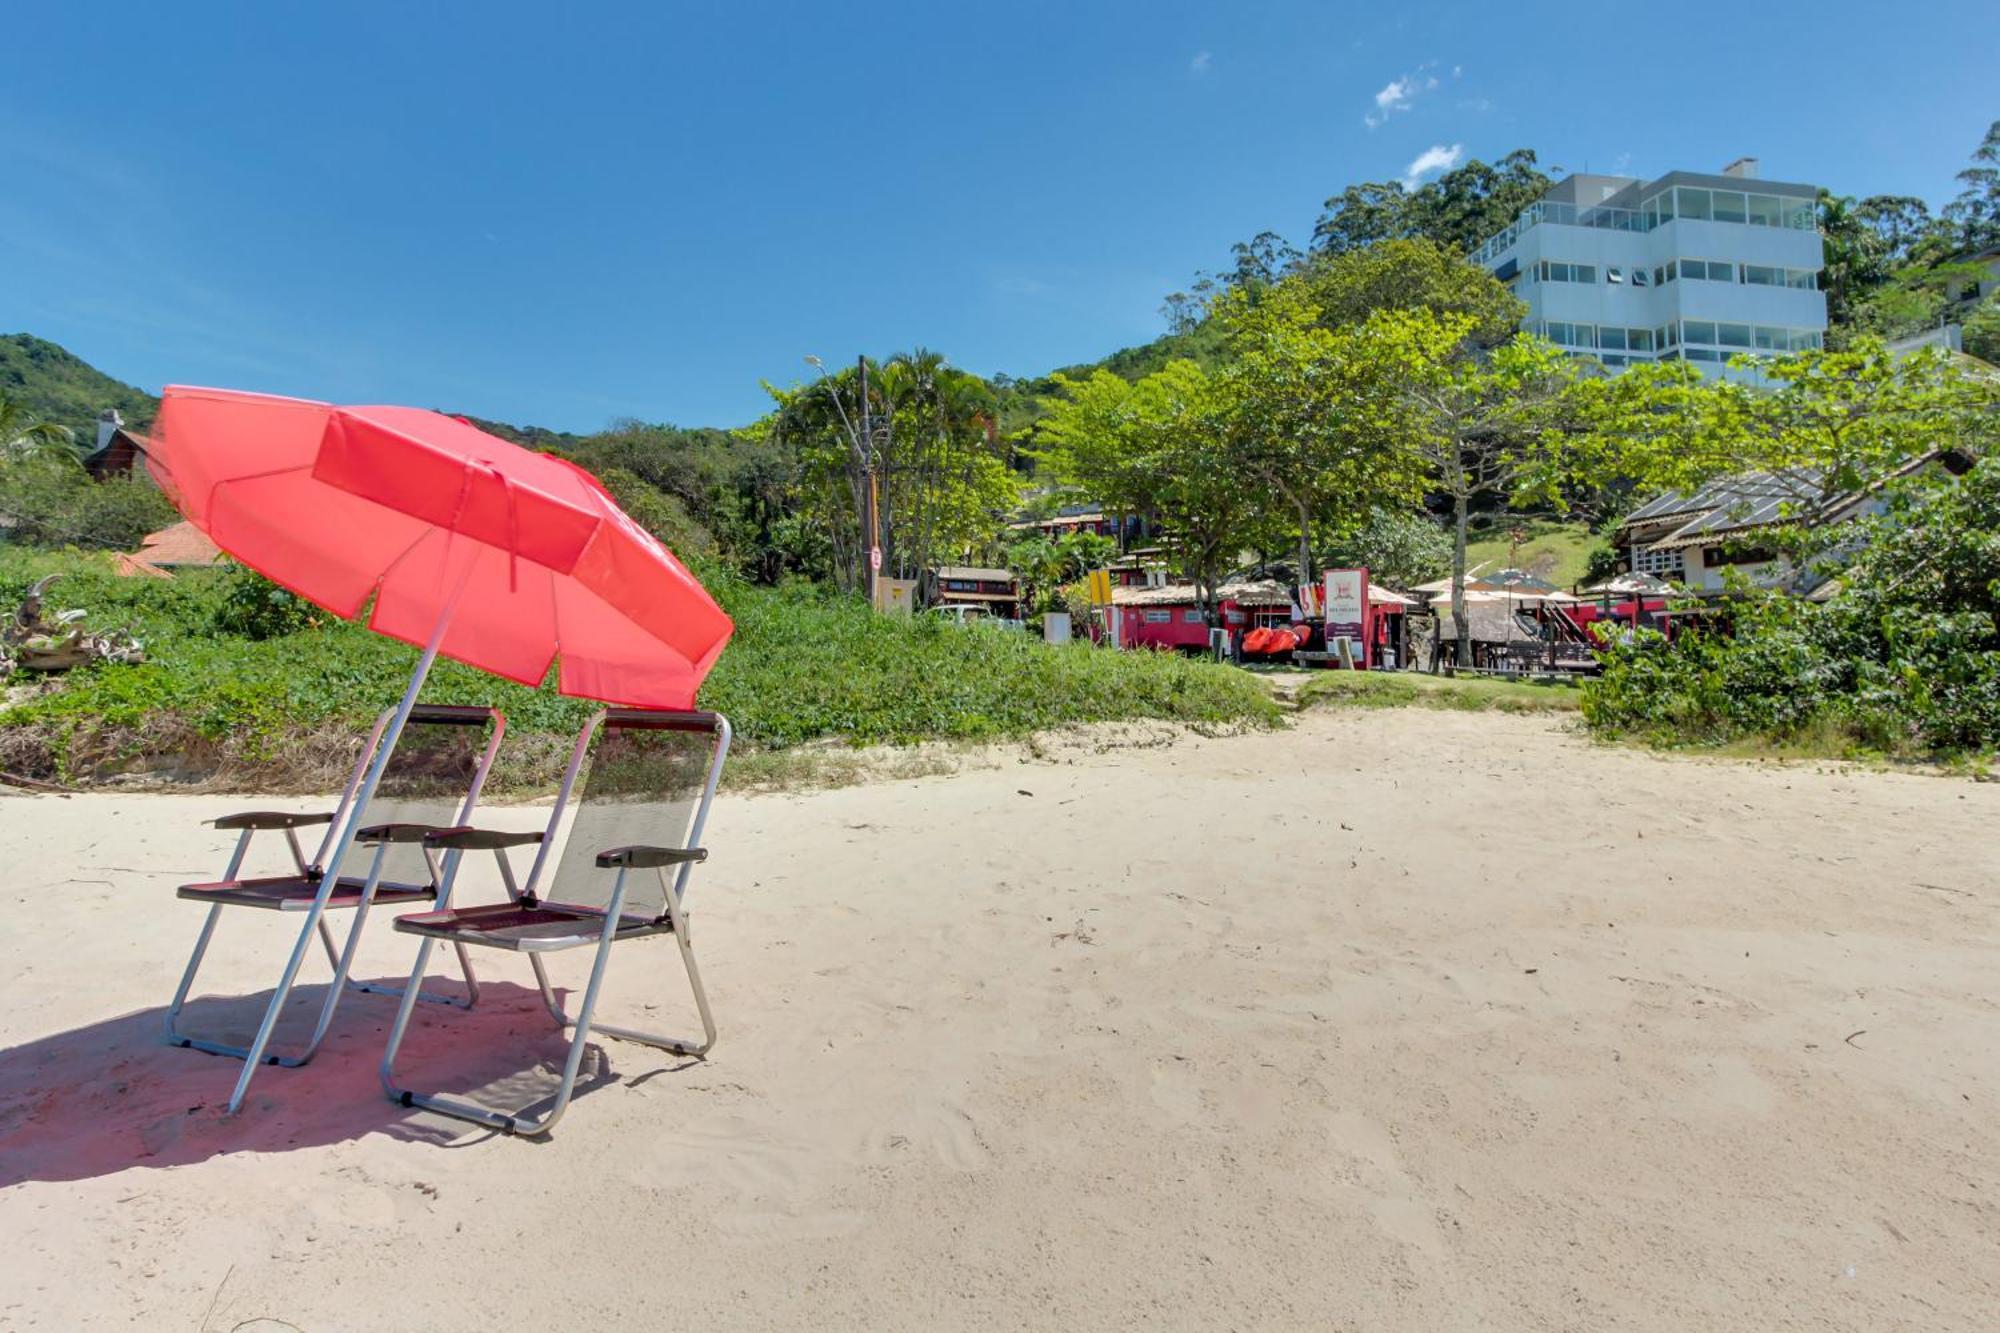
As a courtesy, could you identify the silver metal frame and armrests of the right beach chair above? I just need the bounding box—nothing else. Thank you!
[382,709,732,1135]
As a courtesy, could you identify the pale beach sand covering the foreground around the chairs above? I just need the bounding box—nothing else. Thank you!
[0,713,2000,1331]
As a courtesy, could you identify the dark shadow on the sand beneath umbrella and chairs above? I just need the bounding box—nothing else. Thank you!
[0,977,686,1189]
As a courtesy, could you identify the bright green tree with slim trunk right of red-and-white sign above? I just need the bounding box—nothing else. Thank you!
[1362,310,1586,667]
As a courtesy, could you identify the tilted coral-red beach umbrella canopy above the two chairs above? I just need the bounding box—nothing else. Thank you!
[150,386,732,709]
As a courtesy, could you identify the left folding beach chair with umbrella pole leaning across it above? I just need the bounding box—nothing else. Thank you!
[166,705,506,1111]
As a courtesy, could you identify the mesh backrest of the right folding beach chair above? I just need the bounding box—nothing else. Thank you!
[534,709,730,919]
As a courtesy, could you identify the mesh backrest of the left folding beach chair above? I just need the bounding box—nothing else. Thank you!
[334,705,506,885]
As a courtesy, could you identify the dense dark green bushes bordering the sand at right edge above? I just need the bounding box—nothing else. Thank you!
[1584,460,2000,757]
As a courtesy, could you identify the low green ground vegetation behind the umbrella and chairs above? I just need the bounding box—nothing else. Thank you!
[0,548,1278,791]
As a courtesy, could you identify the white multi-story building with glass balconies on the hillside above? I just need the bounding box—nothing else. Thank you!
[1472,158,1826,378]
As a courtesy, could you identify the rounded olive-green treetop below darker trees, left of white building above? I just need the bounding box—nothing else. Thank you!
[1292,240,1528,346]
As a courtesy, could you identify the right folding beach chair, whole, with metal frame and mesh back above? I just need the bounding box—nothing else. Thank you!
[382,709,730,1135]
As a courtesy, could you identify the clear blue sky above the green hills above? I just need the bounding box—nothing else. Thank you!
[0,0,2000,430]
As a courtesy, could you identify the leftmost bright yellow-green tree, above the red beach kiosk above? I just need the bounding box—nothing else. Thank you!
[1042,360,1258,612]
